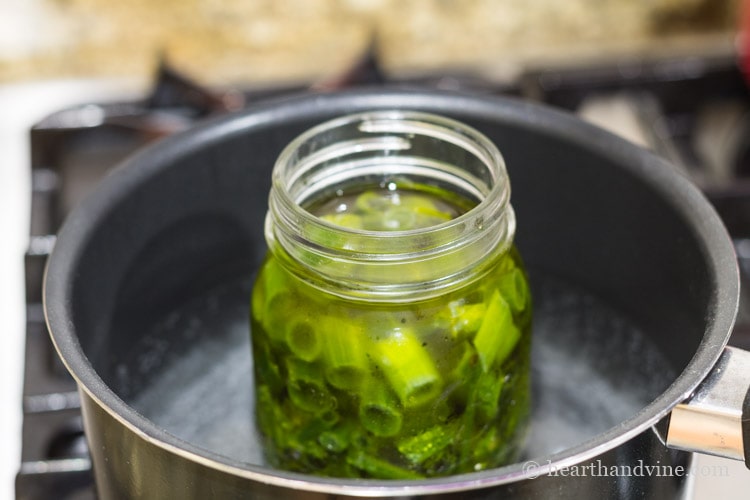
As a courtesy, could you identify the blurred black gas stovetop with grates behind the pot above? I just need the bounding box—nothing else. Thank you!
[10,53,750,500]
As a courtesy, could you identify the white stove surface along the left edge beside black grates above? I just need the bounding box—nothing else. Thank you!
[0,80,144,498]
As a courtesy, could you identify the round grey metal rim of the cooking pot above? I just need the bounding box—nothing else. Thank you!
[43,87,739,497]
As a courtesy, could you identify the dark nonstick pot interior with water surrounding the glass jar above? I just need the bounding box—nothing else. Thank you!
[45,90,738,496]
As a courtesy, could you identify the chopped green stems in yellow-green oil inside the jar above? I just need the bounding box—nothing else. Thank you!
[251,189,531,479]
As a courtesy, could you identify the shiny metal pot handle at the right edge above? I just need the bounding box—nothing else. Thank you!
[666,347,750,469]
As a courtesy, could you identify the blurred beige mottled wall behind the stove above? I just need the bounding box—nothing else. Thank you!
[0,0,738,84]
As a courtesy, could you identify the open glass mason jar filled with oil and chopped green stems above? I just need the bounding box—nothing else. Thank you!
[251,111,531,479]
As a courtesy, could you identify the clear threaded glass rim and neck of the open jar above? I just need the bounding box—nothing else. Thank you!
[265,109,515,300]
